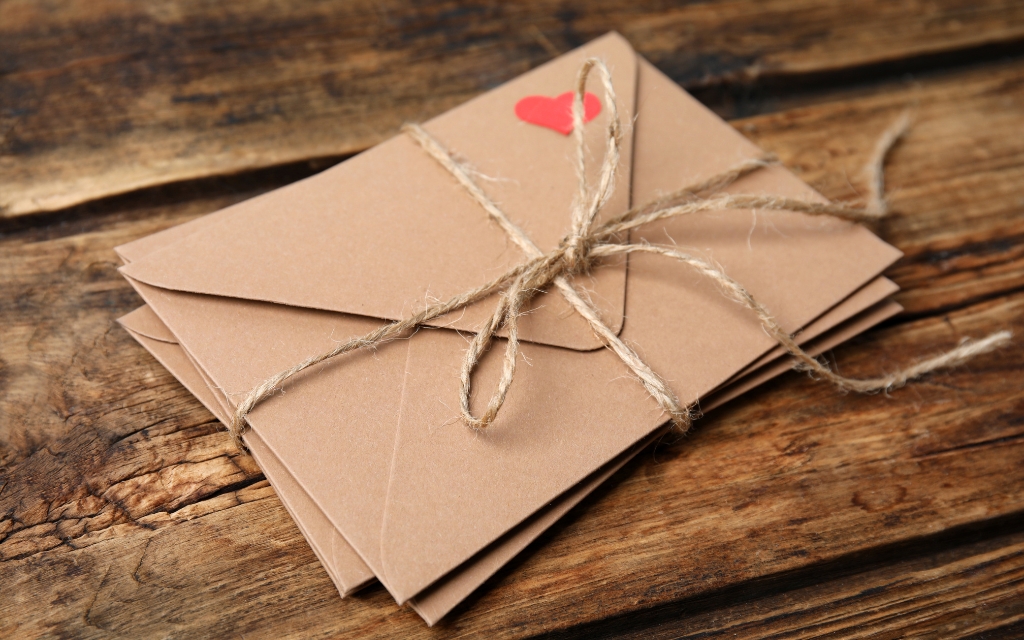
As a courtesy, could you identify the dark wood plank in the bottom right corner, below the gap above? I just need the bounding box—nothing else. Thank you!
[577,534,1024,640]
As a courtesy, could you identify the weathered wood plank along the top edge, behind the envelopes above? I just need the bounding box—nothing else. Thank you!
[0,0,1024,216]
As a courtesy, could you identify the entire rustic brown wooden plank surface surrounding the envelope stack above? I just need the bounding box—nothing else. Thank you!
[0,0,1024,638]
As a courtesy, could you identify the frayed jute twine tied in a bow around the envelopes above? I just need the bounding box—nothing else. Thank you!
[228,58,1011,449]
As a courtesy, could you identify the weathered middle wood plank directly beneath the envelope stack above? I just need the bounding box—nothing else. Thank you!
[0,58,1024,637]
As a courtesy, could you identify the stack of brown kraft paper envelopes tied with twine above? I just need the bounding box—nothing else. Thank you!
[117,34,900,624]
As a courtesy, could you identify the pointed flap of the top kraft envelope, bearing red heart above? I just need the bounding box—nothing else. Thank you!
[122,34,637,349]
